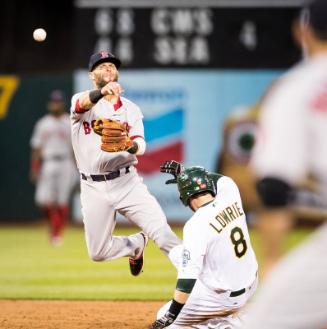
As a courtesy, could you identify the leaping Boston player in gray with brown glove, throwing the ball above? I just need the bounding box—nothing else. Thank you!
[71,51,180,276]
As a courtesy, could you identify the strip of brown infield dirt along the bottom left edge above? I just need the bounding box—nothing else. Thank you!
[0,300,164,329]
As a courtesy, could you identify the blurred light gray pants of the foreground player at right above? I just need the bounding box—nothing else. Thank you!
[240,220,327,329]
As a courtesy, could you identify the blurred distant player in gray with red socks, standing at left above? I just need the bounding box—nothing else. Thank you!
[30,90,77,245]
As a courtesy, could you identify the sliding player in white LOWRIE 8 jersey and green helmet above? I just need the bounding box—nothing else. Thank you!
[150,161,258,329]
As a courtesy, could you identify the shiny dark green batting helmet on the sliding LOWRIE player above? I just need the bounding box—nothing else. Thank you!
[177,166,216,206]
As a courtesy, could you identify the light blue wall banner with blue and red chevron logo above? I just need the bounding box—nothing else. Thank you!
[74,70,281,221]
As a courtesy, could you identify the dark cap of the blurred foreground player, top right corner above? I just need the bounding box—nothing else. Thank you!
[305,0,327,35]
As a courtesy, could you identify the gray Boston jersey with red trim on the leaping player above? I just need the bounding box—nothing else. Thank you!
[70,93,144,174]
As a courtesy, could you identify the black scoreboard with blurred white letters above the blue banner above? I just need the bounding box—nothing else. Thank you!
[73,0,300,68]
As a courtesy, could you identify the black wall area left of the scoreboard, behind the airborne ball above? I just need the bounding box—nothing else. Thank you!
[0,0,74,74]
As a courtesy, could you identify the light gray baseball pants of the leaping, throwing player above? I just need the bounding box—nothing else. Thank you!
[81,167,181,261]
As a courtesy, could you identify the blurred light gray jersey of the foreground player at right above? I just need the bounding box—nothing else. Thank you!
[251,54,327,202]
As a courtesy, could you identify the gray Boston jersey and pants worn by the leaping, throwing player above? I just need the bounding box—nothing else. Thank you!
[71,93,180,261]
